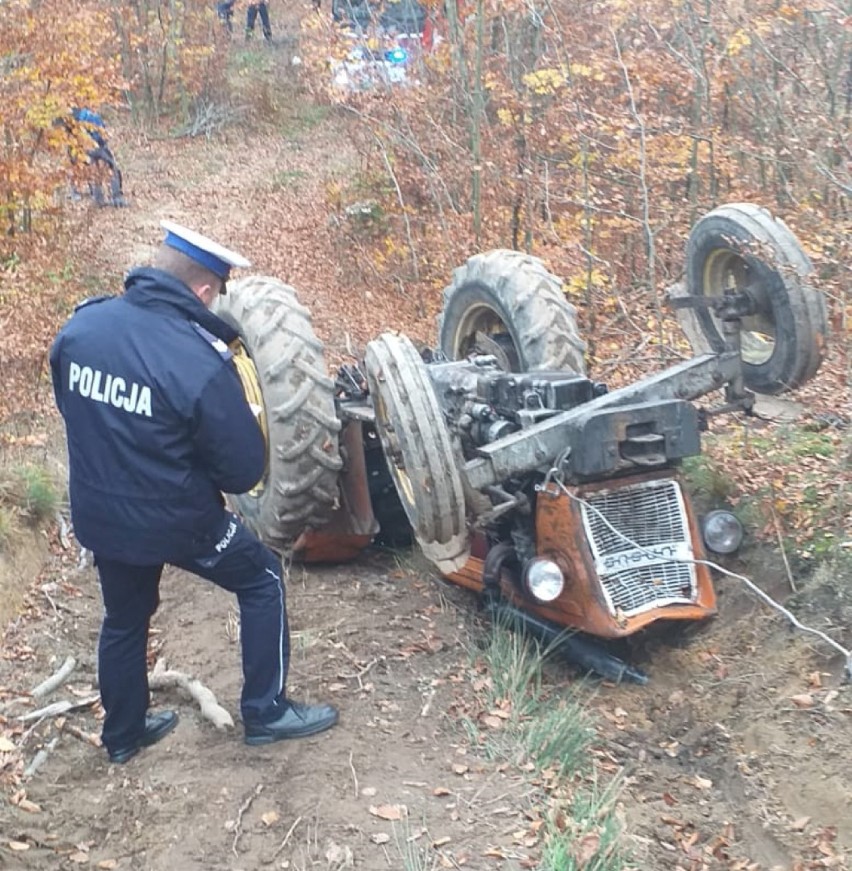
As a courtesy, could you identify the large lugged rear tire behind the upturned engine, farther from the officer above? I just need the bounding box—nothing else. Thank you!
[438,249,586,375]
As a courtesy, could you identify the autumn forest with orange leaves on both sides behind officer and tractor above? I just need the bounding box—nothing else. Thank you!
[0,0,852,557]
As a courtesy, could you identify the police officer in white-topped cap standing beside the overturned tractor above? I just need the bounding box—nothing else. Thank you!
[50,222,338,763]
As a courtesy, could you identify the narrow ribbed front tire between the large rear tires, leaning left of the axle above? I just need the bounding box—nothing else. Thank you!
[365,333,470,574]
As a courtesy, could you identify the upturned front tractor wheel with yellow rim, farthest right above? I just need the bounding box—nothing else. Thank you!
[686,203,828,394]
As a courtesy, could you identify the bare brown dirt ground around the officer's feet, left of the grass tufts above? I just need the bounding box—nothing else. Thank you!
[0,558,524,871]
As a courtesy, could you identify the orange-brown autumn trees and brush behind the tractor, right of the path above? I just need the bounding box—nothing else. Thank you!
[305,0,852,377]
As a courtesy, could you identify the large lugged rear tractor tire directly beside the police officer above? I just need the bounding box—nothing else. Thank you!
[216,276,343,551]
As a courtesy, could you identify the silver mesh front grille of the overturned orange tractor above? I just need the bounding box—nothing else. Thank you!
[583,480,696,617]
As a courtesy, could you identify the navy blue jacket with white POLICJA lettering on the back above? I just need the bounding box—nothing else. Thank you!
[50,268,266,565]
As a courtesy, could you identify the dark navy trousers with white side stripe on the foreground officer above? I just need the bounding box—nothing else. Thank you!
[95,513,290,750]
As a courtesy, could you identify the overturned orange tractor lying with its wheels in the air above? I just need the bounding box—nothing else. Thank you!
[213,204,827,681]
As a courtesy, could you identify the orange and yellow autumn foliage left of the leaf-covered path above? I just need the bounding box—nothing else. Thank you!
[0,0,230,421]
